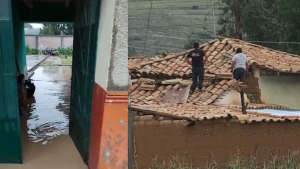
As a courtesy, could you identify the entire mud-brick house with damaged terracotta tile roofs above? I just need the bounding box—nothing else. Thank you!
[128,37,300,168]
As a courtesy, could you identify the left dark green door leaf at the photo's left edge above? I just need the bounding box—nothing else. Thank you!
[0,0,22,163]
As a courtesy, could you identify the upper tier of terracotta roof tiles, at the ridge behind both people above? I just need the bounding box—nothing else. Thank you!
[128,37,300,78]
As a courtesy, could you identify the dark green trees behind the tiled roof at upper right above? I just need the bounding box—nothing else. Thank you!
[218,0,300,54]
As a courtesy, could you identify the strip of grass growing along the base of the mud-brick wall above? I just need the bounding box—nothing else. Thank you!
[149,151,300,169]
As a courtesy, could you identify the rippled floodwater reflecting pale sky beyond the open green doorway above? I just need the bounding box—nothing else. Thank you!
[27,66,72,145]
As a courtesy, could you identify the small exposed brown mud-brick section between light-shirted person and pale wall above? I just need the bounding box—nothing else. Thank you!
[245,74,261,103]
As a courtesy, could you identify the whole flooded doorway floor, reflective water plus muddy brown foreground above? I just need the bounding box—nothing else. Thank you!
[0,66,87,169]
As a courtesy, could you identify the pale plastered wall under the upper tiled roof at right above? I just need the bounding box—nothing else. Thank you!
[259,71,300,109]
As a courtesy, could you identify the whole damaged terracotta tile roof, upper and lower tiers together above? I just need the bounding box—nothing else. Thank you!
[128,38,300,123]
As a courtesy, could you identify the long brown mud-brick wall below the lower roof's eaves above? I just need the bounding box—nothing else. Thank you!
[134,116,300,169]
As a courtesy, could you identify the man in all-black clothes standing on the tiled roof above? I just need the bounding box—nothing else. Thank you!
[185,42,207,93]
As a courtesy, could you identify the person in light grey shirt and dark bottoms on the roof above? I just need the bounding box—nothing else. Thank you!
[231,48,248,82]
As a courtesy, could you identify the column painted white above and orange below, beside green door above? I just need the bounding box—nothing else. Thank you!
[88,0,128,169]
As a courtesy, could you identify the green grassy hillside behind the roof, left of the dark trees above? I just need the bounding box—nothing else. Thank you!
[128,0,220,56]
